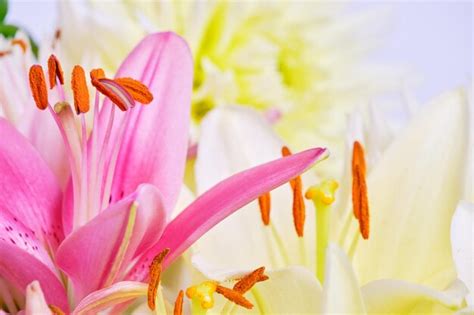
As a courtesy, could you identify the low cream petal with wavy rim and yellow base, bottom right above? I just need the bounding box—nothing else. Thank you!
[362,280,467,314]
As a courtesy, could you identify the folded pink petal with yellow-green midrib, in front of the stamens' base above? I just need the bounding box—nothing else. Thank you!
[56,185,166,299]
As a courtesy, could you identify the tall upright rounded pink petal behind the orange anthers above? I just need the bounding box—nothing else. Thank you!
[101,33,193,212]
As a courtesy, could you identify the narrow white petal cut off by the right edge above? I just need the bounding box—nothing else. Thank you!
[451,201,474,305]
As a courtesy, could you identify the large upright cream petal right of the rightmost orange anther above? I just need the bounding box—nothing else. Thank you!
[352,90,468,289]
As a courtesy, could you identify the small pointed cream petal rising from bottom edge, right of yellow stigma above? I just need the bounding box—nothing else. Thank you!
[322,244,365,314]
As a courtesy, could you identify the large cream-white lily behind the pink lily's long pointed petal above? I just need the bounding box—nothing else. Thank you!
[193,87,470,313]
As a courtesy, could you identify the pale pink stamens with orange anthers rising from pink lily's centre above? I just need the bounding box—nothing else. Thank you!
[29,55,153,230]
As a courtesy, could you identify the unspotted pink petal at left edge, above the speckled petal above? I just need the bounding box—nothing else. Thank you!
[0,118,64,250]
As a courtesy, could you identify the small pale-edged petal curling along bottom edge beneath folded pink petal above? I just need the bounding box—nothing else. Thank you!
[73,281,148,314]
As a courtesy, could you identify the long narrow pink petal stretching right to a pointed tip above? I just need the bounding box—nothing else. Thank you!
[130,148,327,280]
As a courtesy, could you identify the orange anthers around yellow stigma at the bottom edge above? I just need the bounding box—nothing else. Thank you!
[148,249,268,315]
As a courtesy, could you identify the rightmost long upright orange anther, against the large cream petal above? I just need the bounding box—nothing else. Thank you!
[352,141,370,239]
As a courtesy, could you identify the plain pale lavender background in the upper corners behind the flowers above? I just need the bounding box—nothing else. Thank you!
[7,0,473,101]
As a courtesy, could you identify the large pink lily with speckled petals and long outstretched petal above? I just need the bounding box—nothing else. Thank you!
[0,33,326,312]
